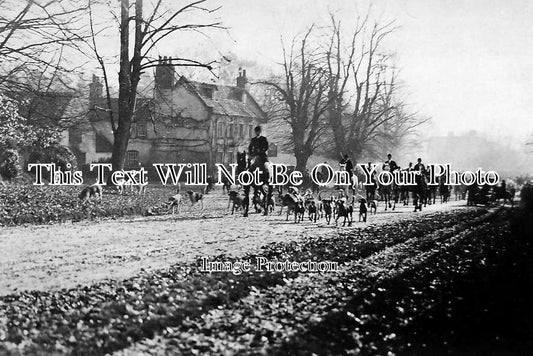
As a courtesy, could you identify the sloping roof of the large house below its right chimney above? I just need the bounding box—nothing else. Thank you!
[176,76,266,121]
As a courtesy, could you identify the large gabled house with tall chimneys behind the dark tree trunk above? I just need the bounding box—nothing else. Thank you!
[69,57,266,168]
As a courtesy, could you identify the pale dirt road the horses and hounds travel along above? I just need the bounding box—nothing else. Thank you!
[0,196,465,295]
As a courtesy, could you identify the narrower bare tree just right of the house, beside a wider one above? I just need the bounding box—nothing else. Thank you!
[261,27,328,172]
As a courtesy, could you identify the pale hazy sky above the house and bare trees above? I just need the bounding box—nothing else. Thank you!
[205,0,533,144]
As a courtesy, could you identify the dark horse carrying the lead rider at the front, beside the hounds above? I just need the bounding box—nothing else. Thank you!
[237,152,273,217]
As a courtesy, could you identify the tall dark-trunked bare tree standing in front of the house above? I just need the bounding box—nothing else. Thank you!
[84,0,222,170]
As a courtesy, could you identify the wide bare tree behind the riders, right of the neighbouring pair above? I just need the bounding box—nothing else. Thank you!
[326,15,427,161]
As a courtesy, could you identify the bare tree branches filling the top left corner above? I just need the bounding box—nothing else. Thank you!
[0,0,87,91]
